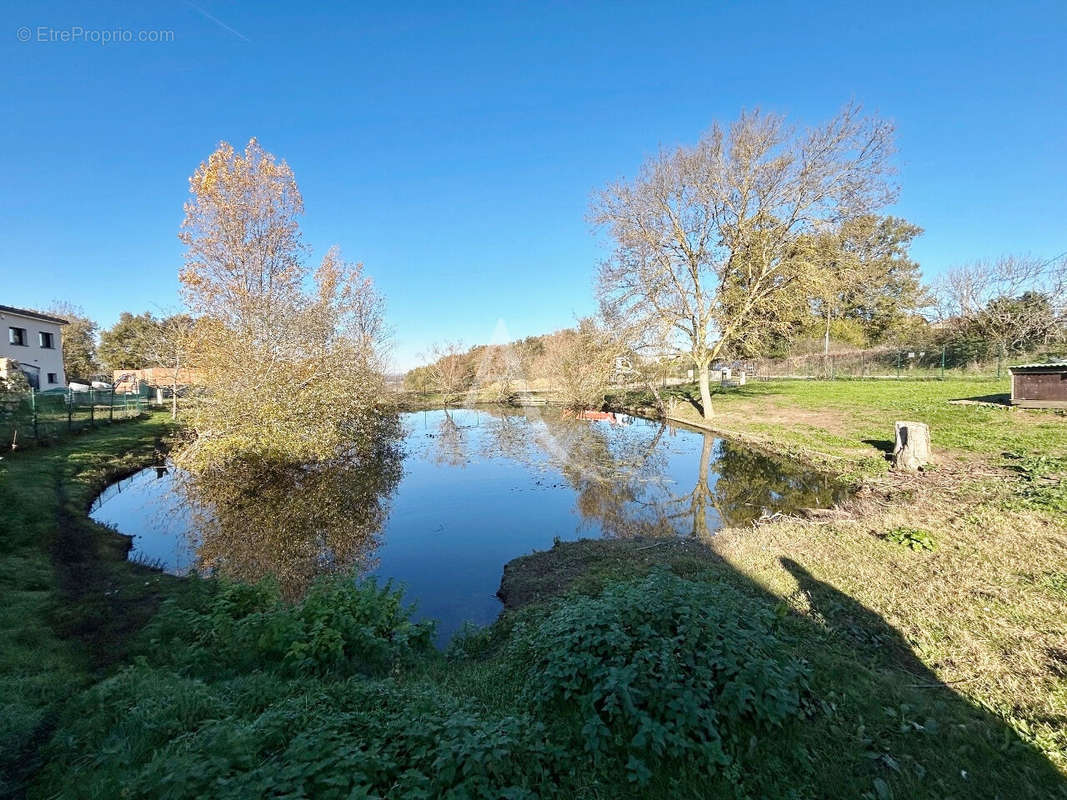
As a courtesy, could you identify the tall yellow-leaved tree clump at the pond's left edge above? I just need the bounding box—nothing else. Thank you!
[177,139,385,471]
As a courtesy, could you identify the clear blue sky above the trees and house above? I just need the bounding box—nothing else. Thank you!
[0,0,1067,367]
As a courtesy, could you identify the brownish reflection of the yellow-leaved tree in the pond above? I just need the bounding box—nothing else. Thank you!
[175,417,403,597]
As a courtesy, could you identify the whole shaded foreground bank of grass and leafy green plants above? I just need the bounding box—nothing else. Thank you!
[34,541,1067,800]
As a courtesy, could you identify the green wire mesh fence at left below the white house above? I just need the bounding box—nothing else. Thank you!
[0,389,148,450]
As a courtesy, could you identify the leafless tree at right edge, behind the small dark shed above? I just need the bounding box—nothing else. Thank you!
[937,256,1067,353]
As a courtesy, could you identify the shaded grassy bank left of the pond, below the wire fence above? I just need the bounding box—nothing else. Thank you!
[0,414,178,796]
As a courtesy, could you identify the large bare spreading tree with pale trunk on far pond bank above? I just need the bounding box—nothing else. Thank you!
[590,105,894,418]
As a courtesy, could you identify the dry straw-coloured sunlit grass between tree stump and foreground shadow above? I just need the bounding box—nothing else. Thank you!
[712,466,1067,771]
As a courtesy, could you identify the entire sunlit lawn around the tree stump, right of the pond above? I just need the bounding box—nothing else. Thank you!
[616,380,1067,771]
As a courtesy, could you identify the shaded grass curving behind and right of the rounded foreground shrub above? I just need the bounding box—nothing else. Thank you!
[501,539,1067,800]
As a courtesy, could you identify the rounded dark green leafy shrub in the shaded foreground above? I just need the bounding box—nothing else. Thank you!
[515,572,807,784]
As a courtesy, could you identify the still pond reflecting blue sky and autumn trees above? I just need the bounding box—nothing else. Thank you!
[91,407,841,642]
